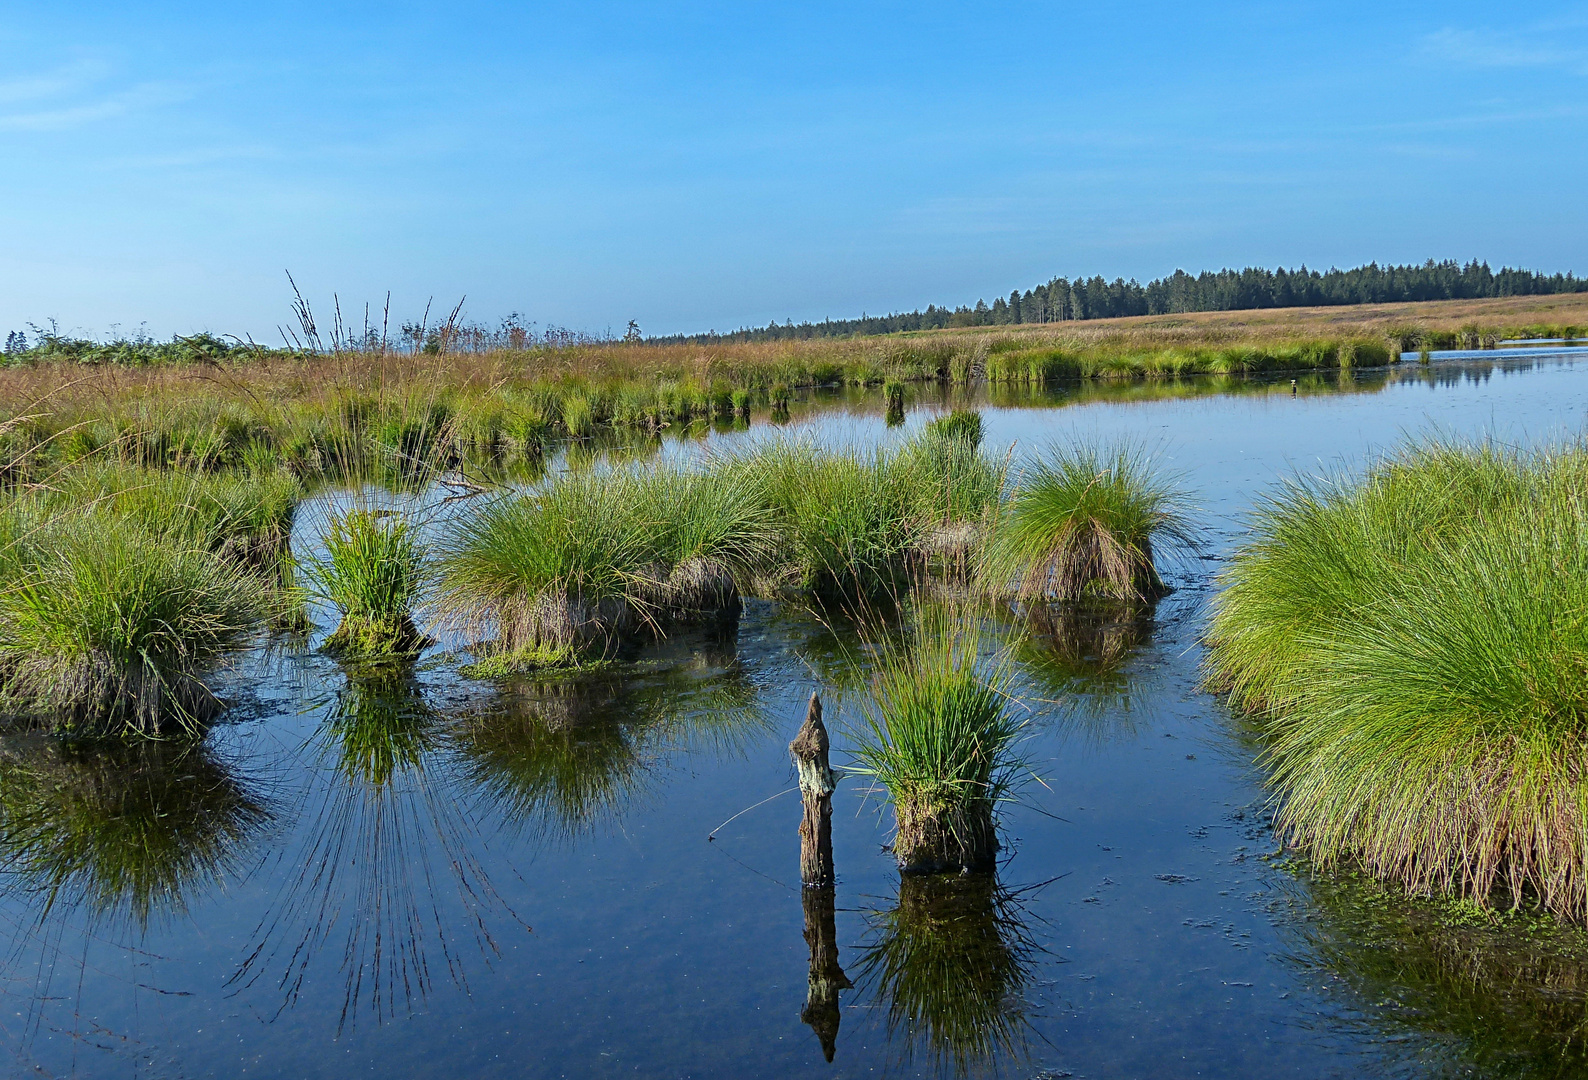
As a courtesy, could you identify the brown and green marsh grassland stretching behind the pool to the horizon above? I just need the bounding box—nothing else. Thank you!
[0,294,1588,478]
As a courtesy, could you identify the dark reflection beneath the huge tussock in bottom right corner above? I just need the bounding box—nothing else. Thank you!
[1288,874,1588,1080]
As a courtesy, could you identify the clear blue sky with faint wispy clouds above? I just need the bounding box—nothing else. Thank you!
[0,2,1588,341]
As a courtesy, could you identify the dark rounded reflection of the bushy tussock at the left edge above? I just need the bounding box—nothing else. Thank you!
[0,734,273,931]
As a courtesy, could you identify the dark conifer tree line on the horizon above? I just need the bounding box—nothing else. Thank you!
[646,259,1588,345]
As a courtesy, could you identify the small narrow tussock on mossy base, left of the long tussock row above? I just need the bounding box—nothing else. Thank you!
[300,508,430,659]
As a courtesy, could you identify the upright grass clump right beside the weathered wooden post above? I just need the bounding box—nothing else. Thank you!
[856,604,1026,874]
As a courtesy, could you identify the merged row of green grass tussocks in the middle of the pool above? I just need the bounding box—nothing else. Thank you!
[440,434,1002,675]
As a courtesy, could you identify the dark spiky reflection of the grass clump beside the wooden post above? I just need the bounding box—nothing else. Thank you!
[854,874,1042,1075]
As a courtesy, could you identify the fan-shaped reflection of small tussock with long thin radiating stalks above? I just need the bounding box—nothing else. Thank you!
[229,667,516,1031]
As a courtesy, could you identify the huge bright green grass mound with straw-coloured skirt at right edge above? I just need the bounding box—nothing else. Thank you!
[1207,440,1588,920]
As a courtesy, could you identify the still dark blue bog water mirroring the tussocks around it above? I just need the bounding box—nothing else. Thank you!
[9,357,1588,1078]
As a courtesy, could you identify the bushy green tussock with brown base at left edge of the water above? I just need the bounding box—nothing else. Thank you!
[0,511,268,734]
